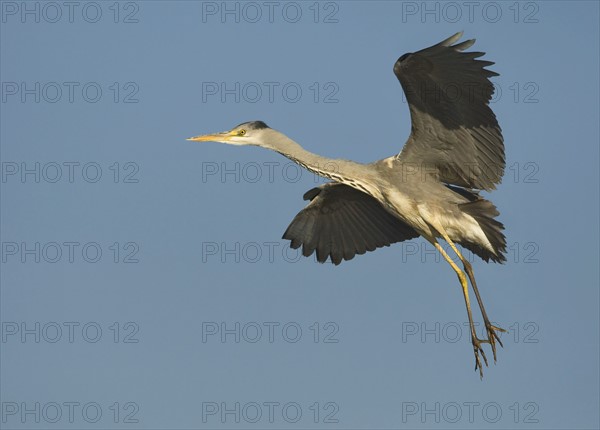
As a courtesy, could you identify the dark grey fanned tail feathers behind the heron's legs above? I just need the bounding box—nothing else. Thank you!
[459,198,506,263]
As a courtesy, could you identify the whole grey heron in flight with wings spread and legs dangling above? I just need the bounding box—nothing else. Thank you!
[188,32,506,377]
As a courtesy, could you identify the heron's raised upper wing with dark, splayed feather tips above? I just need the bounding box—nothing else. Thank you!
[394,32,505,190]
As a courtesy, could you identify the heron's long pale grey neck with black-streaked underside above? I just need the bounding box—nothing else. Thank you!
[268,132,371,186]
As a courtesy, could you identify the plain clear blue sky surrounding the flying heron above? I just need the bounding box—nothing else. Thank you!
[0,1,600,429]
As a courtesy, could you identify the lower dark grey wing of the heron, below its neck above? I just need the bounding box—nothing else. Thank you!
[283,183,419,265]
